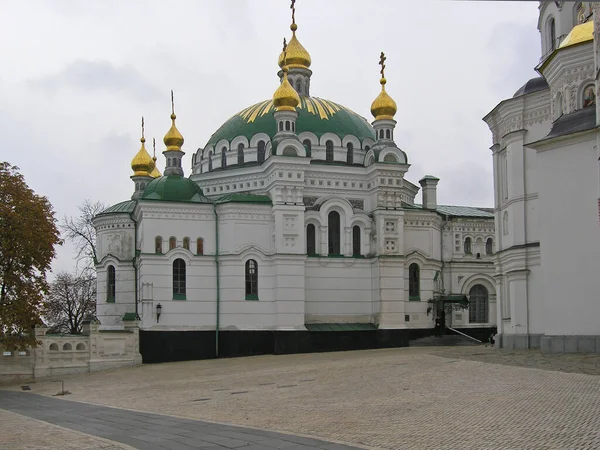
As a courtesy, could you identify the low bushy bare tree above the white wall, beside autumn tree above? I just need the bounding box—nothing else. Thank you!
[45,272,96,334]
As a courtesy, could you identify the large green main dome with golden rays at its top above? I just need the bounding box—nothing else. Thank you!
[206,96,375,147]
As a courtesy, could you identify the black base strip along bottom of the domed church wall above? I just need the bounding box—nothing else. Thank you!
[140,329,418,363]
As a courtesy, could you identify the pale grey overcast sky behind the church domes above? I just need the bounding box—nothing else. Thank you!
[0,0,540,272]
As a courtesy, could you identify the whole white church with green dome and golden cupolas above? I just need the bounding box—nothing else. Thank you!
[94,4,498,361]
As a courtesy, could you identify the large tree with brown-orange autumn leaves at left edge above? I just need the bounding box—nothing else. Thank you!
[0,162,61,350]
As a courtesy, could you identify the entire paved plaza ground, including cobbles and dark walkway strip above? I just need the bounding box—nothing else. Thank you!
[0,346,600,450]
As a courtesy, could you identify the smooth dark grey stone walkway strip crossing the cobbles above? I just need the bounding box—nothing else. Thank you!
[0,391,358,450]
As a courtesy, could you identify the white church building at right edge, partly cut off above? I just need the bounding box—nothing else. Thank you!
[484,1,600,352]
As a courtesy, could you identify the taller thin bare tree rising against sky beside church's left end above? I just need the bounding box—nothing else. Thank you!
[60,200,106,274]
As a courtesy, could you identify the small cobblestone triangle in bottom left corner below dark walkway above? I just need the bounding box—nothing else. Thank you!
[0,410,133,450]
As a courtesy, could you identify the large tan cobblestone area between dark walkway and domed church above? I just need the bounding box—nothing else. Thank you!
[0,346,600,450]
